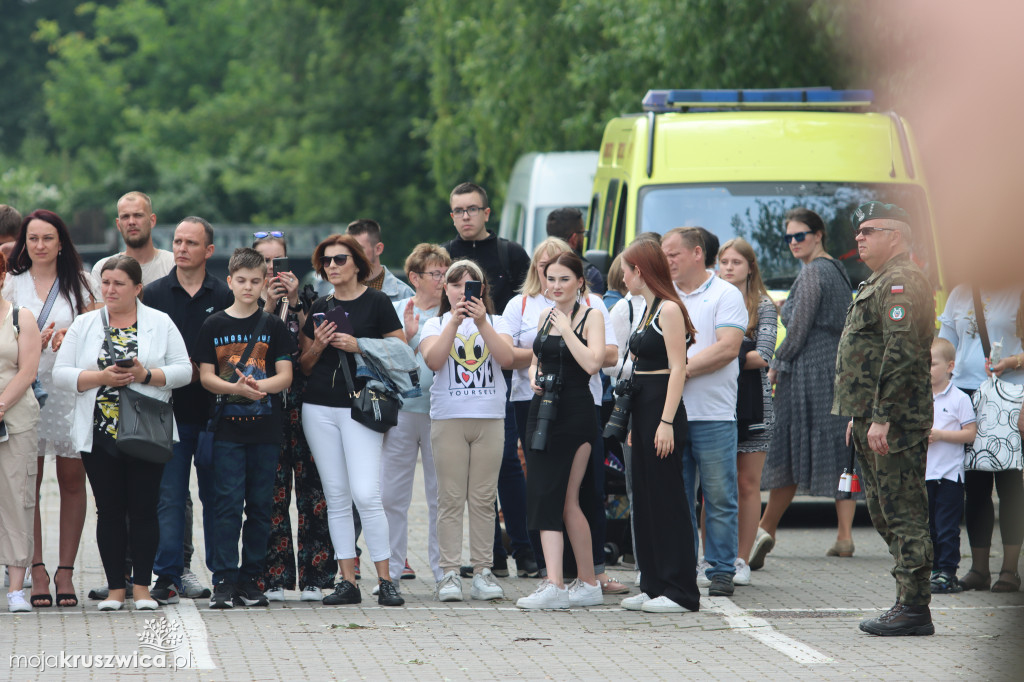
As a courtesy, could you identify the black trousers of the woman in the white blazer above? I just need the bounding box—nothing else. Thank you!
[82,433,164,590]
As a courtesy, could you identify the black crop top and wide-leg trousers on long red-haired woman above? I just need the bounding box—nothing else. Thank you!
[629,303,700,611]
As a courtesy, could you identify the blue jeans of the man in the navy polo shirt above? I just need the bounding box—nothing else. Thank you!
[153,422,209,590]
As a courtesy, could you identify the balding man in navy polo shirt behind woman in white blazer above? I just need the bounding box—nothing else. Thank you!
[142,216,234,604]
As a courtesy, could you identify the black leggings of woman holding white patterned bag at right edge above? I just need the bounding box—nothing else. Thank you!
[964,469,1024,548]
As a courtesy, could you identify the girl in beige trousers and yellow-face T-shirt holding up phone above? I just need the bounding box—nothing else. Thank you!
[420,260,512,601]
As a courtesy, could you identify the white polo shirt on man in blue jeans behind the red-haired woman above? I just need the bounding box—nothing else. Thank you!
[676,274,748,422]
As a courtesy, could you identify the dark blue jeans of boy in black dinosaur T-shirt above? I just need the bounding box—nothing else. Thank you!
[203,440,281,584]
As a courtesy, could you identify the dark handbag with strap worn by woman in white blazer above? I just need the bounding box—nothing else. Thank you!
[100,309,174,464]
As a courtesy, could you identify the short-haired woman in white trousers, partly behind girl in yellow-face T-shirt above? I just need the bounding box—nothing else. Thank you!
[381,243,452,583]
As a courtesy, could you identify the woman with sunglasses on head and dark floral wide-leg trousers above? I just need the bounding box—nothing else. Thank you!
[253,230,337,601]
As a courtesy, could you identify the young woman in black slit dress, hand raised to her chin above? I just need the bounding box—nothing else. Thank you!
[516,252,604,609]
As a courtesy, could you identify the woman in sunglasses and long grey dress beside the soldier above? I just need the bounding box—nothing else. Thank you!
[750,207,863,570]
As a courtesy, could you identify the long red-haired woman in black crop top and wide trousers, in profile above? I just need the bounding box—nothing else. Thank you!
[622,240,700,613]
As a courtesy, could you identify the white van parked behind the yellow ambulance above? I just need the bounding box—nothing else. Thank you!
[499,152,598,254]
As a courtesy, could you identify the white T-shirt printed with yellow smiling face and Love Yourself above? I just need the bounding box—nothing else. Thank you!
[417,311,511,419]
